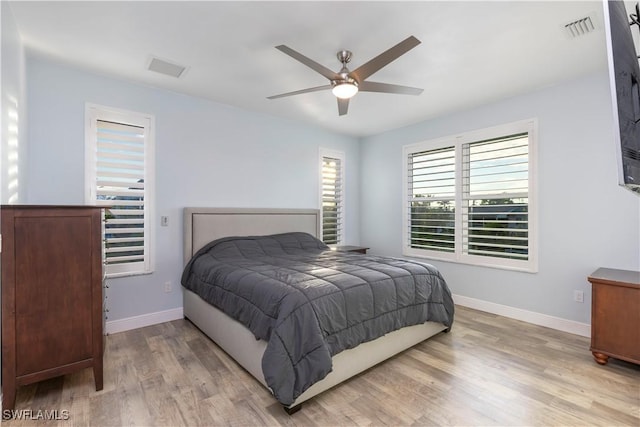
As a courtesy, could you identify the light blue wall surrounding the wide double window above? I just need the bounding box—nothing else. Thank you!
[360,72,640,323]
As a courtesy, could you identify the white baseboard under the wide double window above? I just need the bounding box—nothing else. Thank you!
[453,295,591,337]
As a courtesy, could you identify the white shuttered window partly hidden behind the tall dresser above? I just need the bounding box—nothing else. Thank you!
[85,105,154,277]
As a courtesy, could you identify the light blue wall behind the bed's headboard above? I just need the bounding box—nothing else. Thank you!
[27,55,359,320]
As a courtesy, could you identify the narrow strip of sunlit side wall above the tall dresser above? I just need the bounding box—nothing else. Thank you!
[0,1,27,204]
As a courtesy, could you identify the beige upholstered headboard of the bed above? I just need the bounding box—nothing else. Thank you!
[184,207,320,264]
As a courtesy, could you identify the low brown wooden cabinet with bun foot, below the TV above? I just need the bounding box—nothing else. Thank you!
[588,268,640,365]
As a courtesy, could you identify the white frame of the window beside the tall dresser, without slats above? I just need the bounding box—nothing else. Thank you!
[84,103,155,278]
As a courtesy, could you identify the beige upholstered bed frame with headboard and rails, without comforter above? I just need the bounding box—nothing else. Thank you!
[183,207,446,413]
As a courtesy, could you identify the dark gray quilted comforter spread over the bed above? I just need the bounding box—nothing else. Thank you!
[182,233,454,405]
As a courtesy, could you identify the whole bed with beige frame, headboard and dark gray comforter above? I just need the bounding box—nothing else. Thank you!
[182,208,453,413]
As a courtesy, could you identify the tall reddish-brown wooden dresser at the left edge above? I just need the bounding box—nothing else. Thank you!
[0,206,103,409]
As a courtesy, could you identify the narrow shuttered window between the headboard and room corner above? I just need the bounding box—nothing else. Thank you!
[320,149,344,245]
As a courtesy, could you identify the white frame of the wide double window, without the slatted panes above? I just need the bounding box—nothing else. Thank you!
[402,118,538,273]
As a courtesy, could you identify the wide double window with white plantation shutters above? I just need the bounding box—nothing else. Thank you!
[403,120,537,272]
